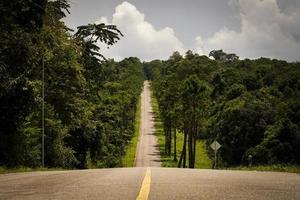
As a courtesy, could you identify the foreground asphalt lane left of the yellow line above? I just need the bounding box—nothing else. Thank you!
[0,168,145,200]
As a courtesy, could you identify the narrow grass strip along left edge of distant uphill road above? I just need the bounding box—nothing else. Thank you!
[122,97,141,167]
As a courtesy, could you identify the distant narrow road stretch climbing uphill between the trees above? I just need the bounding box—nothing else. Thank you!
[135,81,161,167]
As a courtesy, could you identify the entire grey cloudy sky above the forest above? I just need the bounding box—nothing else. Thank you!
[65,0,300,61]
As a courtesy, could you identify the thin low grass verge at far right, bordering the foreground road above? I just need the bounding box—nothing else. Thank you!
[226,165,300,174]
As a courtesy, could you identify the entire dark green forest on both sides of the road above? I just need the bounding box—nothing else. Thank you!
[0,0,300,169]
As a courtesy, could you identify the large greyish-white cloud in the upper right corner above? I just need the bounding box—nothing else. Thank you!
[195,0,300,61]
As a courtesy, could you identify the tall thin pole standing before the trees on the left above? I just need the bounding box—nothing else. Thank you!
[42,54,45,168]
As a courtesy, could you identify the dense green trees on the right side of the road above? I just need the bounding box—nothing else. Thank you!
[144,50,300,168]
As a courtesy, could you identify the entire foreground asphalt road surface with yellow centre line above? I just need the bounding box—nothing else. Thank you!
[0,167,300,200]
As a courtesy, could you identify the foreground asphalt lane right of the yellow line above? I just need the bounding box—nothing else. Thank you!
[149,168,300,200]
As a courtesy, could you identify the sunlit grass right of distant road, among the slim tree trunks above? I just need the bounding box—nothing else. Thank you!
[151,90,212,169]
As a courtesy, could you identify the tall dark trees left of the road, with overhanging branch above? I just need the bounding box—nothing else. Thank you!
[0,0,144,168]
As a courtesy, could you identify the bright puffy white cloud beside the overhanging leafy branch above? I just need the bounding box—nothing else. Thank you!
[96,2,184,60]
